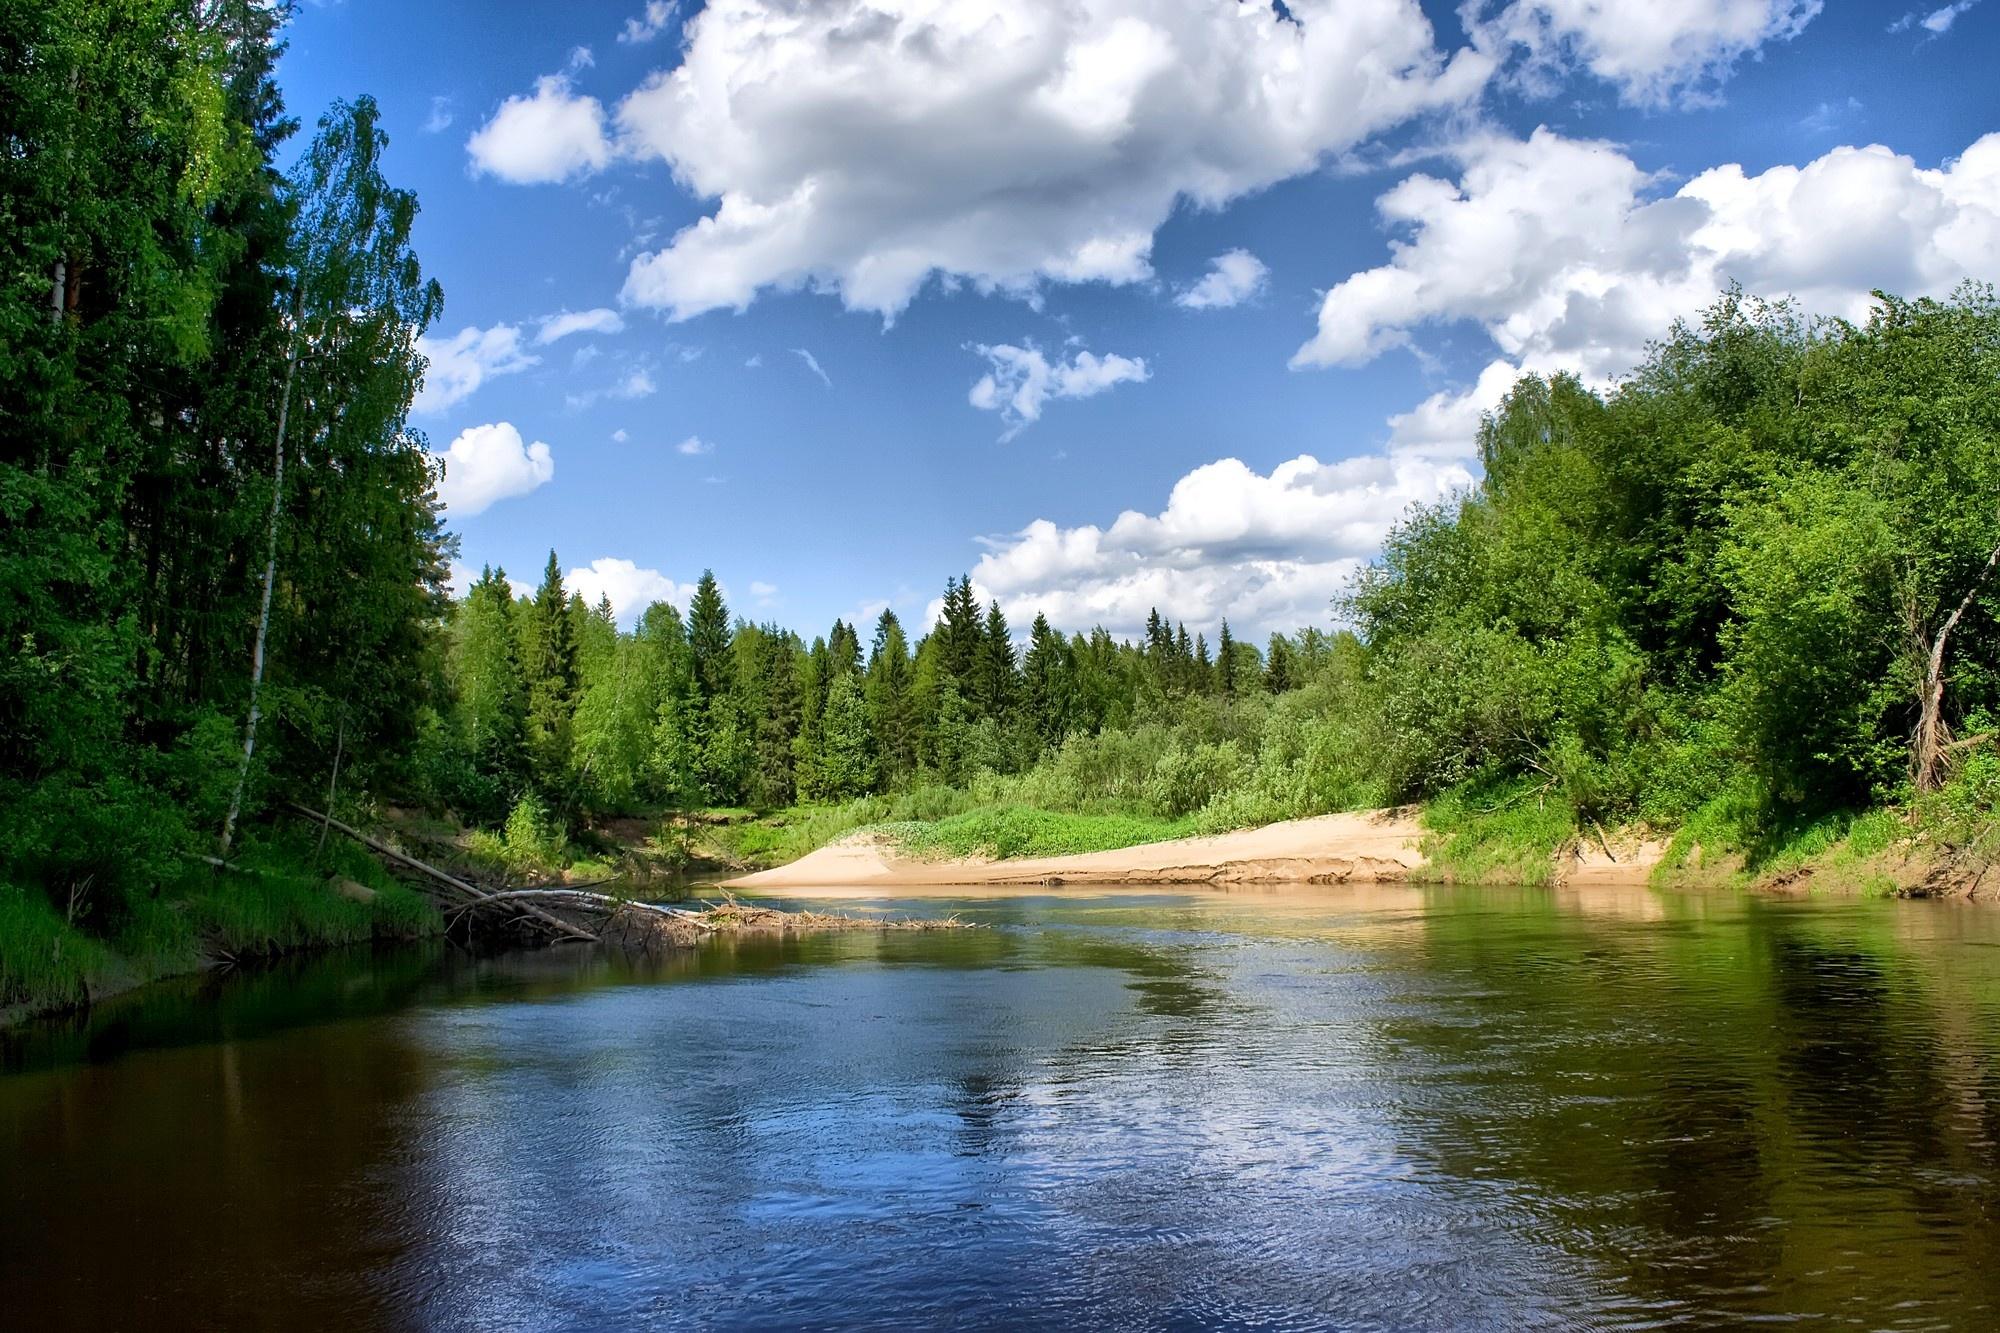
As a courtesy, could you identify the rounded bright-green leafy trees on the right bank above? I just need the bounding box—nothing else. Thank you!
[1350,284,2000,831]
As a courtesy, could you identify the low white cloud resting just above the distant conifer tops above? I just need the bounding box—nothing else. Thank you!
[930,454,1472,636]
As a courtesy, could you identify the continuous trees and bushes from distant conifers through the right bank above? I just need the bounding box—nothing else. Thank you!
[424,286,2000,860]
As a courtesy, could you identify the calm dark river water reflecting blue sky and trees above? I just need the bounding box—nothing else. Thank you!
[0,889,2000,1329]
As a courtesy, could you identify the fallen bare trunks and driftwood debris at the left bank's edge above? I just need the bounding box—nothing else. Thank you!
[290,801,966,951]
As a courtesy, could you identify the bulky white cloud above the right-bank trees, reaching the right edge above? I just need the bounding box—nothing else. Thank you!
[1292,130,2000,382]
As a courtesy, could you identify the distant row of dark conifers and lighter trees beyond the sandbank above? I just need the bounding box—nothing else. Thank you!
[422,552,1328,823]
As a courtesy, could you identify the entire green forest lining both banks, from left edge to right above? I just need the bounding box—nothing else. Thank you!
[0,0,2000,1009]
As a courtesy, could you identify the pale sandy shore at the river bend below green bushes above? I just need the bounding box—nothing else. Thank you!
[726,811,1664,897]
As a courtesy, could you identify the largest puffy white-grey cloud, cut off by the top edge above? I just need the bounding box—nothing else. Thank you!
[616,0,1494,318]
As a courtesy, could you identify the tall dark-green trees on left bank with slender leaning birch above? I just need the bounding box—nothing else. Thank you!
[0,0,448,944]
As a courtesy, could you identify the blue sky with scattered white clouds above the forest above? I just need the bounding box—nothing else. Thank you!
[280,0,2000,636]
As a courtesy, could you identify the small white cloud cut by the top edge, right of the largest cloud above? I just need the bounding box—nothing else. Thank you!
[1462,0,1820,106]
